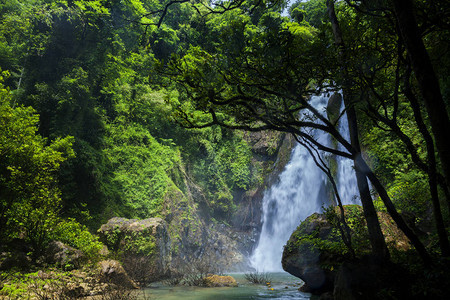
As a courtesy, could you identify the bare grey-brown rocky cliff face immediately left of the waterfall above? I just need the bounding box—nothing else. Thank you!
[175,131,295,270]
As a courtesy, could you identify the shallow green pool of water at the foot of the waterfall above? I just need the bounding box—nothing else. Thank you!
[141,273,311,300]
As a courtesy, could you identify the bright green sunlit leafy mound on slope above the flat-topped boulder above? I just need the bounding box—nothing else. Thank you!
[105,123,180,218]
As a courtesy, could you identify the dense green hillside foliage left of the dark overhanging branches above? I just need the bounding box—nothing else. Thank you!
[0,0,261,258]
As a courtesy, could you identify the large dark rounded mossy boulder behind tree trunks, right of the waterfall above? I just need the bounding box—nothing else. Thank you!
[282,205,410,299]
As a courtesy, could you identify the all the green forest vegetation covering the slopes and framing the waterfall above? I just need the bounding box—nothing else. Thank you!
[0,0,450,298]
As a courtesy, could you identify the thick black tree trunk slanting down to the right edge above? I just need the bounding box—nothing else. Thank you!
[393,0,450,192]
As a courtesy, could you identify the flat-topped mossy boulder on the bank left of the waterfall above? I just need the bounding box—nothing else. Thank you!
[98,218,170,283]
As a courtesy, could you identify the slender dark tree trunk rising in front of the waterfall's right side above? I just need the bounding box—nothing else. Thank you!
[327,0,389,261]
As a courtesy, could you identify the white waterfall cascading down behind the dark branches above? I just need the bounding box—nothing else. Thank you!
[250,95,357,272]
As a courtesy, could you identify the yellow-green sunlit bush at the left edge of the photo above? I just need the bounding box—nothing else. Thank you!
[0,74,73,252]
